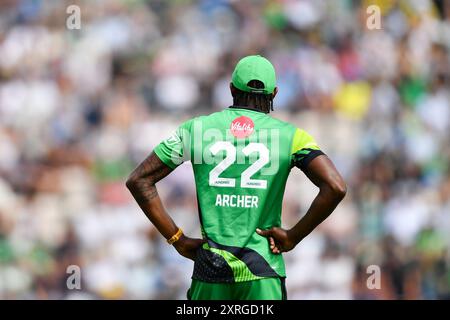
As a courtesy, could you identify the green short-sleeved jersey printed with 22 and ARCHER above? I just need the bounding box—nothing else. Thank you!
[154,107,323,283]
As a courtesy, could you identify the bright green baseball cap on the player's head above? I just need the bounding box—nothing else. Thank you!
[231,55,277,94]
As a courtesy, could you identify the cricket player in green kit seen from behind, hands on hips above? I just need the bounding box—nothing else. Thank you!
[126,55,346,300]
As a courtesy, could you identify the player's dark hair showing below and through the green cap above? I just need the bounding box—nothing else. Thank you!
[233,80,273,113]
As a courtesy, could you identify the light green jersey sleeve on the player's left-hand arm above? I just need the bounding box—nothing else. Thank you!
[153,120,191,169]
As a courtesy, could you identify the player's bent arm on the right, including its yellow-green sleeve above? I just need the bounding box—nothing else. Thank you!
[257,131,347,253]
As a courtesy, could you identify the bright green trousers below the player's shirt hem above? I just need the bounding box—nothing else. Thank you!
[187,278,286,300]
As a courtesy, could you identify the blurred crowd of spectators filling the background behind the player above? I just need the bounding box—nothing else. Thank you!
[0,0,450,299]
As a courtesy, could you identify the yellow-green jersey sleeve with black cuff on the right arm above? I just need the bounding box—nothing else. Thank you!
[291,129,324,171]
